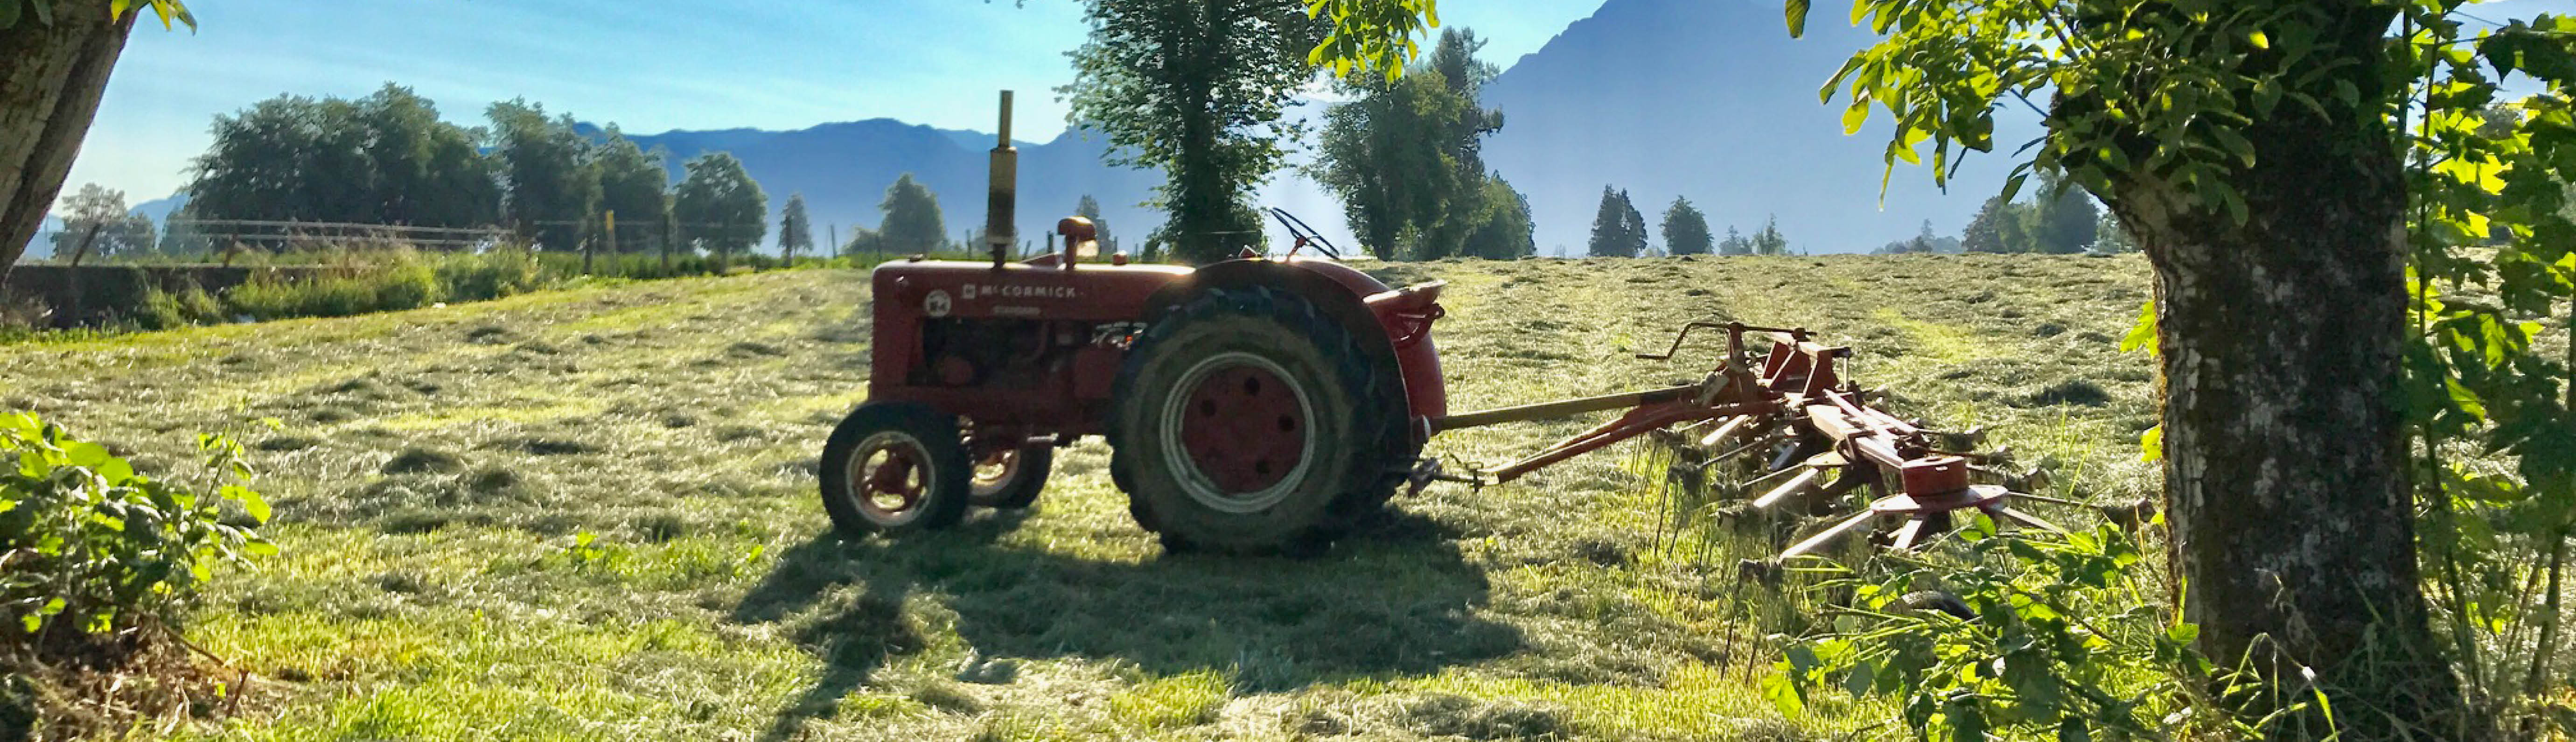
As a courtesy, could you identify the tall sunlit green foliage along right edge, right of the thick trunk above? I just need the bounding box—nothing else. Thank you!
[2396,3,2576,714]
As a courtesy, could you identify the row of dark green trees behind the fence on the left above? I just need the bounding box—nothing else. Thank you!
[183,85,773,255]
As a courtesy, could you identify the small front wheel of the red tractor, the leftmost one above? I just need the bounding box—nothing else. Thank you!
[822,402,974,539]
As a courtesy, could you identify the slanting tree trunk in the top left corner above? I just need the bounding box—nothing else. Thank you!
[0,0,139,278]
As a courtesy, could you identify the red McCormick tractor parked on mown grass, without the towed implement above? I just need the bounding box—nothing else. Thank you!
[822,219,1448,549]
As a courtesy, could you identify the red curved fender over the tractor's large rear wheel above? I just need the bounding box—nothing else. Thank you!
[1144,258,1448,435]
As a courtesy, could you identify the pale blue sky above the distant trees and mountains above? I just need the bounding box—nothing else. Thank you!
[64,0,1600,203]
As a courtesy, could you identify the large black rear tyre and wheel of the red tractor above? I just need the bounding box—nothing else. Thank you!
[1110,286,1409,551]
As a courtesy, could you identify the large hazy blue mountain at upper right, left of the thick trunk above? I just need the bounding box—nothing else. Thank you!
[1484,0,2038,255]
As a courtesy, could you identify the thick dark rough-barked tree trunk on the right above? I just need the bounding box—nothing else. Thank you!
[2102,13,2463,739]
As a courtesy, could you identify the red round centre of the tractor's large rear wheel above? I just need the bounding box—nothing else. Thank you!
[1180,355,1309,495]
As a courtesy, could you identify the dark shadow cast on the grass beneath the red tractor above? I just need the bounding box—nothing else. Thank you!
[732,513,1525,739]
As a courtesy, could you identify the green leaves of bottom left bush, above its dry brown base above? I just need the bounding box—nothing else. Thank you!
[0,412,276,651]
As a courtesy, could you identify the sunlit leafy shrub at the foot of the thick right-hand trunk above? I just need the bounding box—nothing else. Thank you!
[1765,525,2321,739]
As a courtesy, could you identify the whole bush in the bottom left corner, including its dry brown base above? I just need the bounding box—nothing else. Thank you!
[0,415,276,739]
